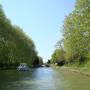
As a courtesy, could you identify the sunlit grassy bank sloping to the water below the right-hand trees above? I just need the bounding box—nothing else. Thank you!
[51,63,90,77]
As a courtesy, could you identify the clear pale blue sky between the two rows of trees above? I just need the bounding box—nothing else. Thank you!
[0,0,75,61]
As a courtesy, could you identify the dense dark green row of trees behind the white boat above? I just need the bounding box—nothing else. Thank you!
[0,5,42,68]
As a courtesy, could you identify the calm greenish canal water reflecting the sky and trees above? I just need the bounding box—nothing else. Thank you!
[0,67,90,90]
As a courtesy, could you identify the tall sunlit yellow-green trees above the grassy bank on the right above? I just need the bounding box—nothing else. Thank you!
[52,0,90,65]
